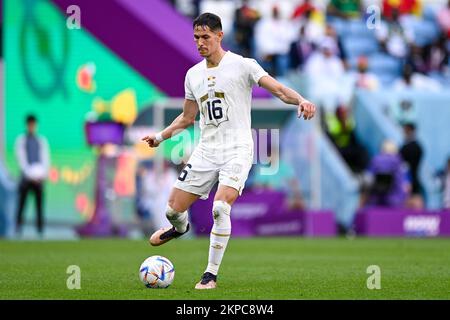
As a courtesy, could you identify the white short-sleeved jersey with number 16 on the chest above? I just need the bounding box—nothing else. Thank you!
[185,51,267,159]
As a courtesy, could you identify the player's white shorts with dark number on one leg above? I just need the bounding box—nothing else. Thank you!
[174,148,253,200]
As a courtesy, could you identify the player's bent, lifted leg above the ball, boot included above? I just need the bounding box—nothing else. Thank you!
[149,187,200,246]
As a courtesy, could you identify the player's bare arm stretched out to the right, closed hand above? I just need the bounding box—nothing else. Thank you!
[259,76,316,120]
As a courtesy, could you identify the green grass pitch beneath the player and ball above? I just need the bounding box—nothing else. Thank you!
[0,238,450,300]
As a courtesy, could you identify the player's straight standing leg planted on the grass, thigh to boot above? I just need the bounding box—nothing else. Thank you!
[195,185,239,289]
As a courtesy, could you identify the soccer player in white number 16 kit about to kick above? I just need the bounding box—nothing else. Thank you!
[142,13,315,289]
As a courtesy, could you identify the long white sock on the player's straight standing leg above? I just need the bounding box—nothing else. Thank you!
[205,201,231,275]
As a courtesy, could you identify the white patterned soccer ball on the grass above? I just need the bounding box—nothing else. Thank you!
[139,256,175,288]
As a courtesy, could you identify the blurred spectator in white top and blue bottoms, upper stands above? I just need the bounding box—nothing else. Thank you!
[255,6,293,77]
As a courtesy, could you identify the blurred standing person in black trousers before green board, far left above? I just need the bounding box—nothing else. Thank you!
[15,115,50,237]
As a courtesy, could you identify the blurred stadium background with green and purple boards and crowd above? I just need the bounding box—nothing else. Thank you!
[0,0,450,239]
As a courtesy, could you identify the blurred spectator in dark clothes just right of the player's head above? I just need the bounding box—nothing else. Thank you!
[234,0,261,57]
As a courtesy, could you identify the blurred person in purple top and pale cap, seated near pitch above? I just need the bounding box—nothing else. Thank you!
[366,141,411,207]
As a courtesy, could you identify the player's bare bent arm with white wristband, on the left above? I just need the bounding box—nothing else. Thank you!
[142,99,198,148]
